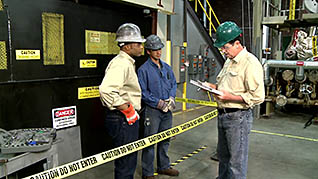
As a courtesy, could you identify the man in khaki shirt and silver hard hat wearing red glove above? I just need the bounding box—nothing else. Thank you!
[99,23,146,179]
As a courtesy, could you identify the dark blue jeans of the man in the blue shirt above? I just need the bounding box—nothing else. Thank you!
[142,106,172,176]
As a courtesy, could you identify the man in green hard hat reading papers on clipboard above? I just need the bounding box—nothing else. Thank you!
[206,21,265,179]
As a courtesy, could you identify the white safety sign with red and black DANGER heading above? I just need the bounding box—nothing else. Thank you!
[52,106,77,129]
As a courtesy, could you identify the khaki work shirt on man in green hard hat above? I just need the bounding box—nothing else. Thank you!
[216,48,265,109]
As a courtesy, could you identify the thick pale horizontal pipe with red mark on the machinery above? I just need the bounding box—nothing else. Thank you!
[263,60,318,86]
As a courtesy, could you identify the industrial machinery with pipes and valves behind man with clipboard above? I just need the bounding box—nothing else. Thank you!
[261,0,318,115]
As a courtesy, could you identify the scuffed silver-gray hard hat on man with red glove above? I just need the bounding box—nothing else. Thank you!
[116,23,146,43]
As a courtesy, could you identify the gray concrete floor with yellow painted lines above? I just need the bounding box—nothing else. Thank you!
[69,107,318,179]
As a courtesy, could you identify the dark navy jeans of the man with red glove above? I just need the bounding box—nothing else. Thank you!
[105,110,139,179]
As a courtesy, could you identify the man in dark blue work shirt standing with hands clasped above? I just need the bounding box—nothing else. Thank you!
[138,35,179,179]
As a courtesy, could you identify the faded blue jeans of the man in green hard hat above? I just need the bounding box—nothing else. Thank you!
[217,109,253,179]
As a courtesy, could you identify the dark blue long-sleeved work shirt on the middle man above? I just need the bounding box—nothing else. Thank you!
[138,58,177,108]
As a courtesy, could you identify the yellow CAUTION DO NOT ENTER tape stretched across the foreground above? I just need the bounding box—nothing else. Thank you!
[23,110,218,179]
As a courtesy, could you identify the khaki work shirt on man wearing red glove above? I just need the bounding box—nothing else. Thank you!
[99,51,141,110]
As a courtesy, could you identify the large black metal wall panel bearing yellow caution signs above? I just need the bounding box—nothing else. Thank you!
[0,0,152,156]
